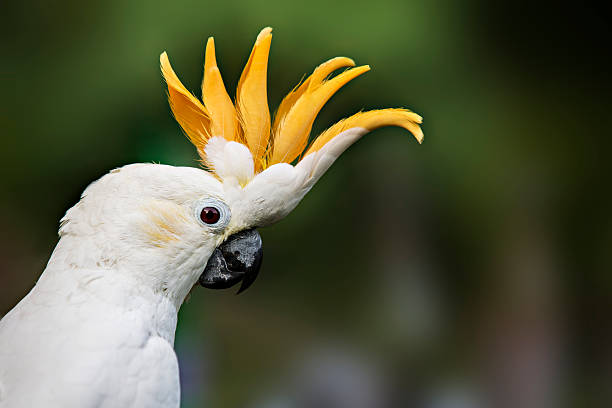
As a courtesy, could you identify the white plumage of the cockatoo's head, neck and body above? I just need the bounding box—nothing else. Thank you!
[0,129,362,408]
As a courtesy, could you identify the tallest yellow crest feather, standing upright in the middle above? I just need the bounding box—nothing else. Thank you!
[236,27,272,168]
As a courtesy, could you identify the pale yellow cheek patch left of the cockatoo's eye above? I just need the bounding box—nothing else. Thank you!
[141,200,189,248]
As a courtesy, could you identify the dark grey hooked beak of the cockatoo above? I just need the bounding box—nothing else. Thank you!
[199,229,263,293]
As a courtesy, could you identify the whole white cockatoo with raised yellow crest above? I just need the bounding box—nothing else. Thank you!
[0,28,423,408]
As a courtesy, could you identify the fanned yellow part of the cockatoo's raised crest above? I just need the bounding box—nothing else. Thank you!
[160,27,423,172]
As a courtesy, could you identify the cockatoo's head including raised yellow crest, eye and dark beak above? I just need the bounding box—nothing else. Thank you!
[60,28,423,301]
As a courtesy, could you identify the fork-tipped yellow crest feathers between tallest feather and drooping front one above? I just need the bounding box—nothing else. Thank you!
[269,63,370,164]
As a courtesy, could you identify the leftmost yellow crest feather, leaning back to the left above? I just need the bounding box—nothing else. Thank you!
[159,52,210,160]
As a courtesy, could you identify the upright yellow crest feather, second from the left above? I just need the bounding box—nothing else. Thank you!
[202,37,238,141]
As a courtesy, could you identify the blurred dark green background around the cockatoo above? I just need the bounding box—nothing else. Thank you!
[0,0,612,408]
